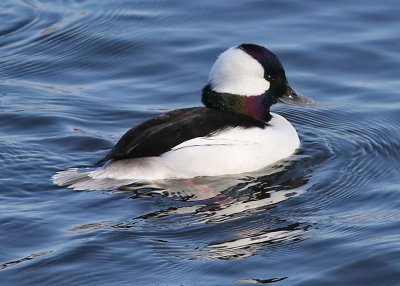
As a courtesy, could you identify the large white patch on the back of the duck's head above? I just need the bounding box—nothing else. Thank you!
[208,47,269,96]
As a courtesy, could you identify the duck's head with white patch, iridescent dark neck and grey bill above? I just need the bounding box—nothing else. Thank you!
[202,44,315,121]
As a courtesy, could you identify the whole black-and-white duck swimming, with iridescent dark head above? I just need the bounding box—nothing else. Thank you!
[53,44,315,189]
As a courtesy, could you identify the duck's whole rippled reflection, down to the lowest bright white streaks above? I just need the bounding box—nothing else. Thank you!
[113,162,310,260]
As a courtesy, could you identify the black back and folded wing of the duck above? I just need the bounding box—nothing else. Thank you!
[97,107,265,164]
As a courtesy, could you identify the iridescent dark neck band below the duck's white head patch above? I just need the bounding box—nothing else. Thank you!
[202,84,272,122]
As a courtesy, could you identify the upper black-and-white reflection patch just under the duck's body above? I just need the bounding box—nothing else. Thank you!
[128,166,308,223]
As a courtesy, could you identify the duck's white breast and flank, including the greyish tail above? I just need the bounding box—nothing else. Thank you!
[53,113,300,189]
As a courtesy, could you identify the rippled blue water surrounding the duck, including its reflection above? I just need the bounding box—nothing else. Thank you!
[0,0,400,286]
